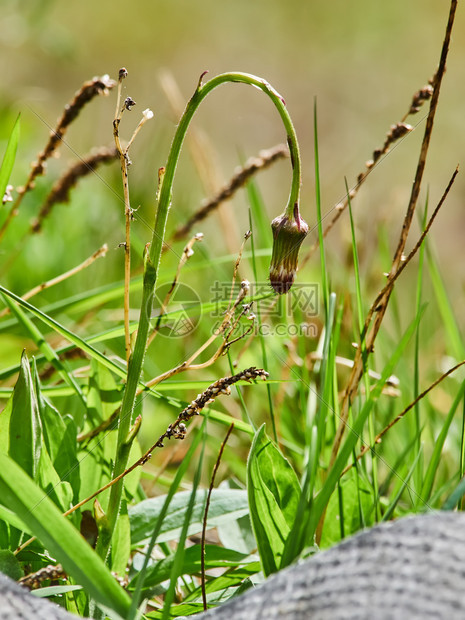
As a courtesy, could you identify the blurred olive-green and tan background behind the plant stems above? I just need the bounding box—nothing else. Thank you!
[0,0,465,320]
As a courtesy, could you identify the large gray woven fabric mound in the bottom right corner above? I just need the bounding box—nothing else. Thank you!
[199,512,465,620]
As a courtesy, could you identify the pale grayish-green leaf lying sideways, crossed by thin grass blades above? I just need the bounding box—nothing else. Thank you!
[129,489,249,546]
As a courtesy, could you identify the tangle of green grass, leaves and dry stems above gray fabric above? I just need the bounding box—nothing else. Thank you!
[0,1,465,618]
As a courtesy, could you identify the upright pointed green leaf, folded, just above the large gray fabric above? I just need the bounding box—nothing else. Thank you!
[247,425,300,576]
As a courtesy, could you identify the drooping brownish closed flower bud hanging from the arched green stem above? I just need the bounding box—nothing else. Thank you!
[270,204,308,295]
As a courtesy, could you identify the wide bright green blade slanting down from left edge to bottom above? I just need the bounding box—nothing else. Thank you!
[0,454,130,617]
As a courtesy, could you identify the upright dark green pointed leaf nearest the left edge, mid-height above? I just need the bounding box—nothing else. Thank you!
[8,352,42,478]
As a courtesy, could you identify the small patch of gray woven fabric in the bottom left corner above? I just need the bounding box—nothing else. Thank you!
[0,573,76,620]
